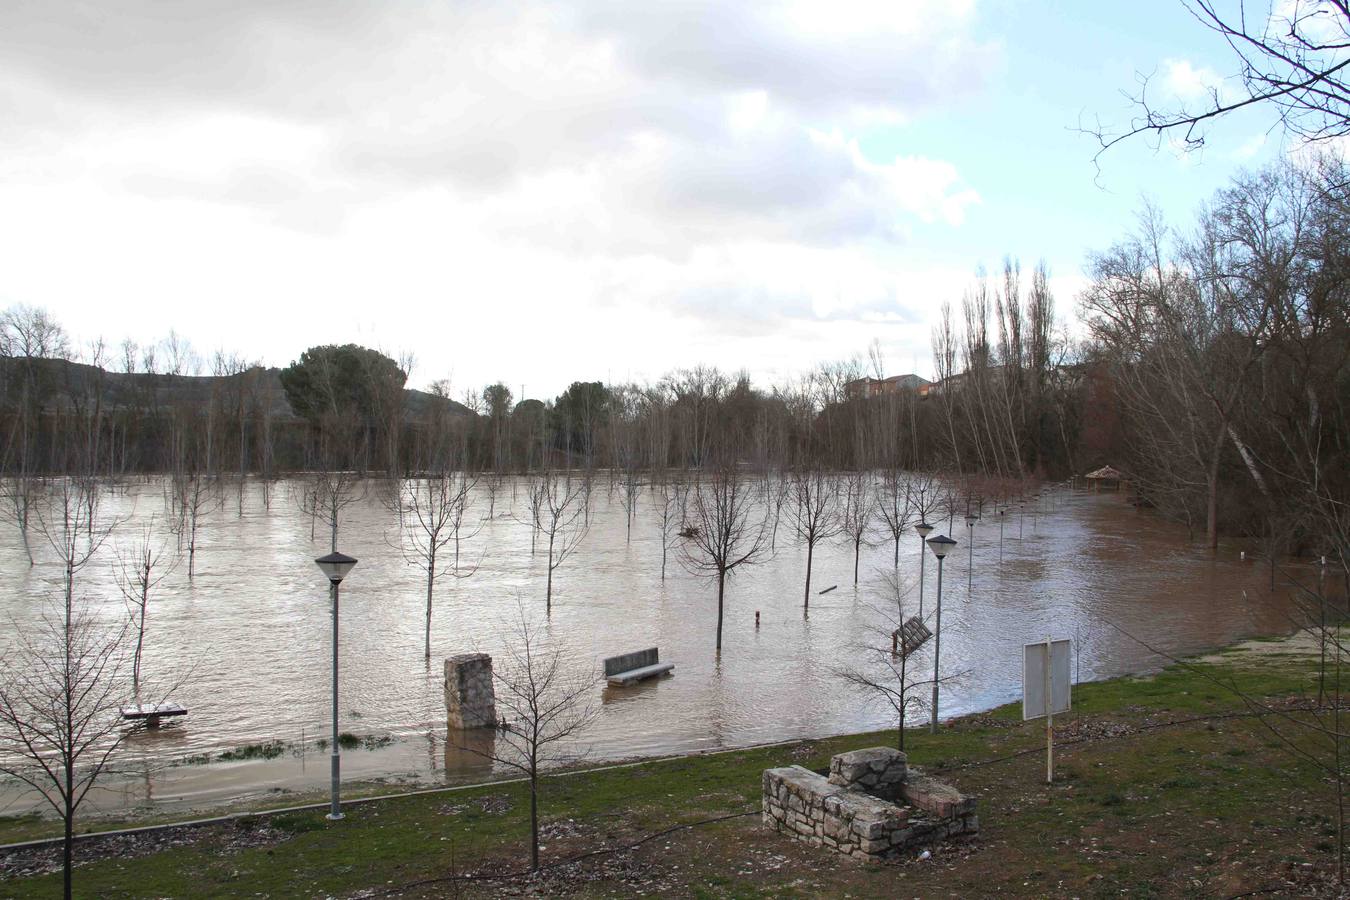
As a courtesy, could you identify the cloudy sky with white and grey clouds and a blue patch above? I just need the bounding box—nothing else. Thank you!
[0,0,1280,397]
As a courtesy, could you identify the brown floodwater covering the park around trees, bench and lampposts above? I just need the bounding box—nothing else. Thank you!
[0,479,1315,812]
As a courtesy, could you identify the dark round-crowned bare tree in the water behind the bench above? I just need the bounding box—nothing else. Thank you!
[680,466,768,653]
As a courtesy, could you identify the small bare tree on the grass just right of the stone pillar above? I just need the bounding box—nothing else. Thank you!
[462,602,599,870]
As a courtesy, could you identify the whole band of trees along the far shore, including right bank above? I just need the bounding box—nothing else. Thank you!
[0,161,1350,564]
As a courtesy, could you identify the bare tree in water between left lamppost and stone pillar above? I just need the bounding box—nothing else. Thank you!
[396,472,482,660]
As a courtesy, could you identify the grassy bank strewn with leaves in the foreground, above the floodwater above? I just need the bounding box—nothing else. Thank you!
[0,631,1337,897]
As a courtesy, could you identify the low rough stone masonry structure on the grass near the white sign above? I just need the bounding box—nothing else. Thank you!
[763,748,980,861]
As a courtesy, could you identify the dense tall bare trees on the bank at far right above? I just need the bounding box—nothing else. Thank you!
[1080,158,1350,559]
